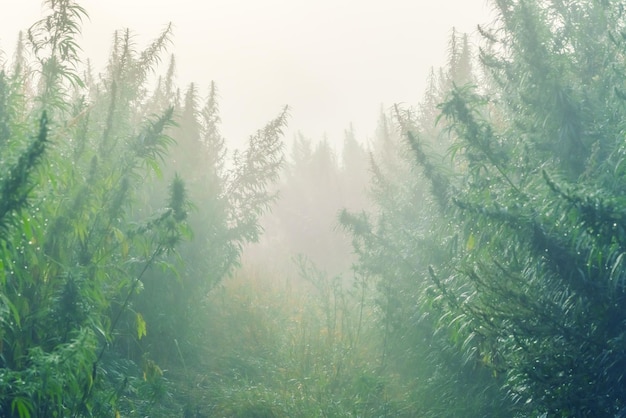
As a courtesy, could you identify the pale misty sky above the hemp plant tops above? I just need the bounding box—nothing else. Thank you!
[0,0,489,146]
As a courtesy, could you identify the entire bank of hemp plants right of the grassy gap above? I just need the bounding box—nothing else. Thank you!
[342,0,625,417]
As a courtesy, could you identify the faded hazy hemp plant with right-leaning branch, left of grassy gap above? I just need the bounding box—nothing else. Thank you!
[129,77,287,382]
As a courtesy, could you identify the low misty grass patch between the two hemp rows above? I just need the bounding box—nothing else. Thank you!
[180,259,412,417]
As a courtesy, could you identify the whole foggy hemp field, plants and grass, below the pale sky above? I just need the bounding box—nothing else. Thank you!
[0,0,626,418]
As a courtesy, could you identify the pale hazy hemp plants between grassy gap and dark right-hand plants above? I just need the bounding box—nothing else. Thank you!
[341,102,510,417]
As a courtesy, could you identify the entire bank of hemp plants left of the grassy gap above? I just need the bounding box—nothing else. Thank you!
[0,1,286,417]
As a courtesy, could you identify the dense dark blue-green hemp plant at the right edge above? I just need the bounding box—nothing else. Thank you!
[424,1,624,416]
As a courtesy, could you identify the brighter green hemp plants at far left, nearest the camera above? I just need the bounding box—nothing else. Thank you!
[0,7,185,417]
